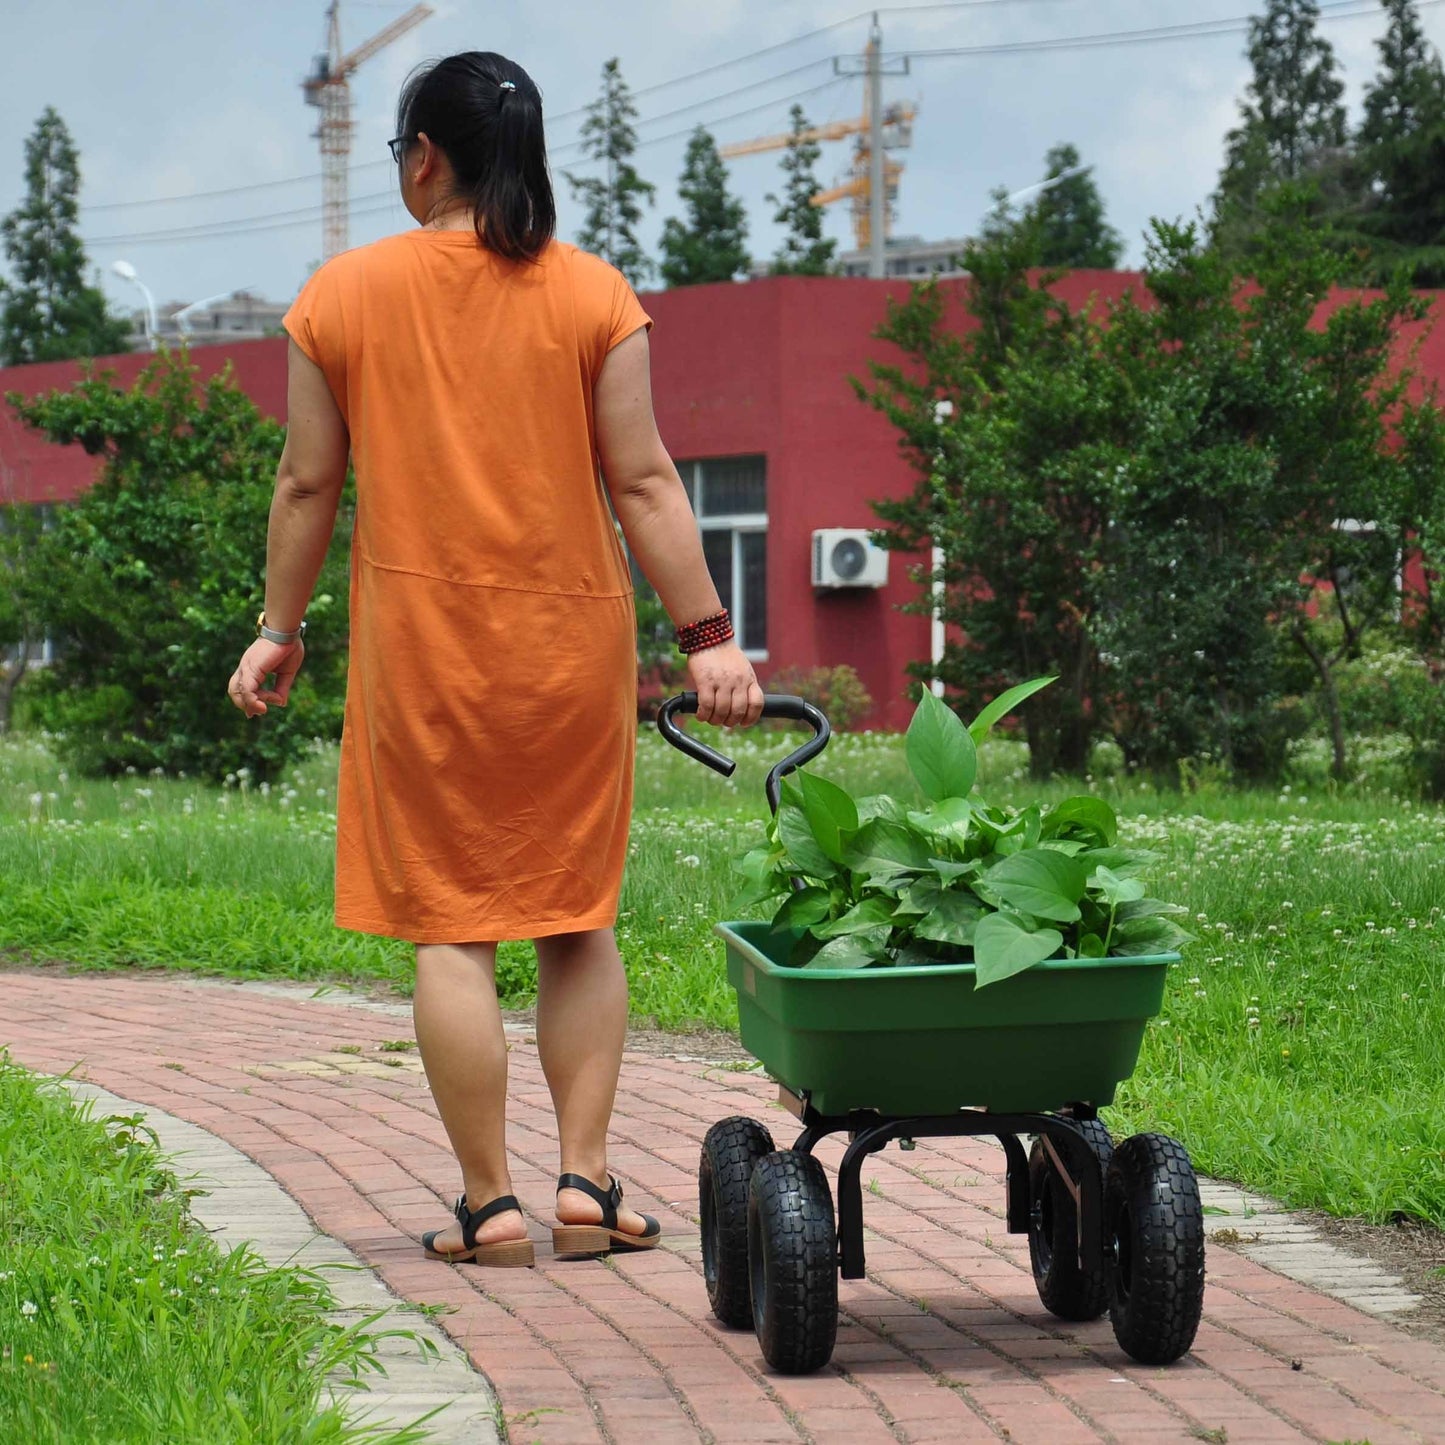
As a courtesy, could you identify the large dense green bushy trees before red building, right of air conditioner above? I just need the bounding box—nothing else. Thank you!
[855,188,1445,777]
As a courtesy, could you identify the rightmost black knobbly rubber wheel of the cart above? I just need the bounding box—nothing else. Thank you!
[1104,1134,1204,1364]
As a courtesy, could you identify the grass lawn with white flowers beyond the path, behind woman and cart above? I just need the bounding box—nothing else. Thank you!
[0,733,1445,1225]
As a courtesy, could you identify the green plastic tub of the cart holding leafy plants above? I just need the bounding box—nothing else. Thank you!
[714,922,1179,1116]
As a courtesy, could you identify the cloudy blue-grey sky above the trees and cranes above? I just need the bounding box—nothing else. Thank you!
[0,0,1445,311]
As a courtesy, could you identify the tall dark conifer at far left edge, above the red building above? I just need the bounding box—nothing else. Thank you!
[0,107,130,366]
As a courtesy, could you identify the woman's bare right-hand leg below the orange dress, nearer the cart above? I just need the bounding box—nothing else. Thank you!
[536,928,644,1234]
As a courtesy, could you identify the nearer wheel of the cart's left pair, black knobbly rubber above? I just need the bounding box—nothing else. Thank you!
[747,1149,838,1374]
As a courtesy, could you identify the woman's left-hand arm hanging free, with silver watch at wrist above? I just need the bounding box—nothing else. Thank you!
[227,341,351,717]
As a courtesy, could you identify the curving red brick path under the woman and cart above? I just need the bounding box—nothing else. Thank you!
[0,971,1445,1445]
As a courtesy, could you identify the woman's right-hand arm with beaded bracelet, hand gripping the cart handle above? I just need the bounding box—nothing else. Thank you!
[592,329,763,727]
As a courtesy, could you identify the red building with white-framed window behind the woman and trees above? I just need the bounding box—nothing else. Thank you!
[0,272,1445,728]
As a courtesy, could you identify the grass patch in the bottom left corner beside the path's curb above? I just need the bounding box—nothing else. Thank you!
[0,1053,426,1445]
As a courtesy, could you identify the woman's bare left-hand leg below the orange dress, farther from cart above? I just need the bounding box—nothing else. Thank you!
[412,944,527,1253]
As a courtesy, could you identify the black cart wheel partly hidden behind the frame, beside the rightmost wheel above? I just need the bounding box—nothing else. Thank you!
[1029,1118,1114,1321]
